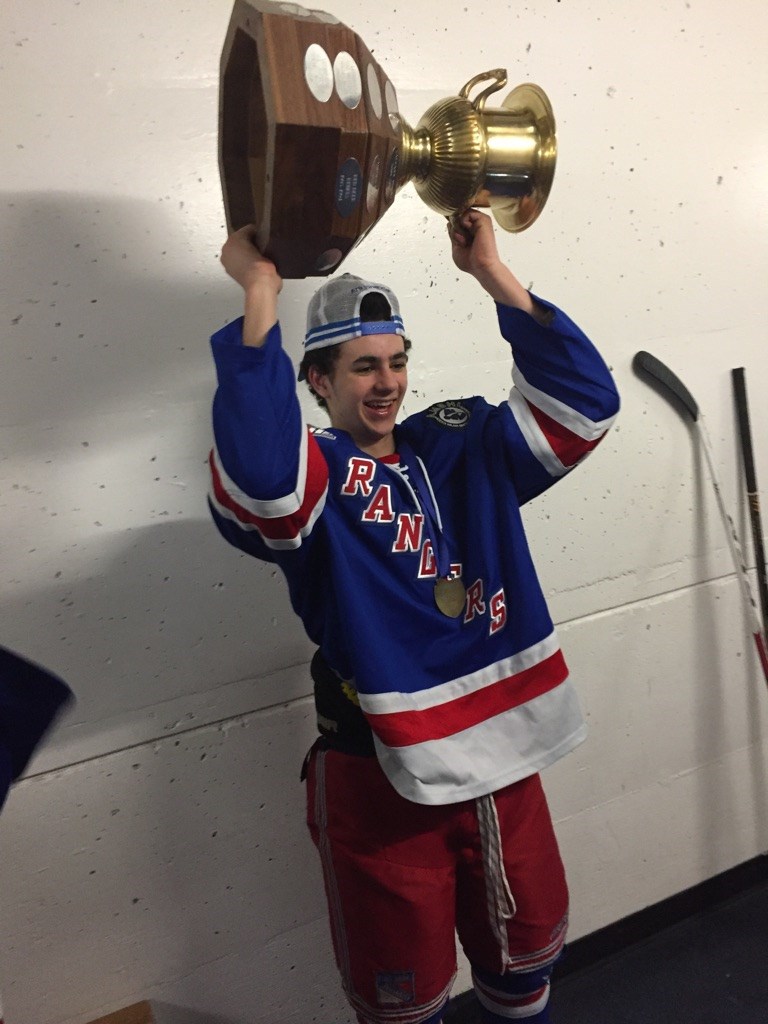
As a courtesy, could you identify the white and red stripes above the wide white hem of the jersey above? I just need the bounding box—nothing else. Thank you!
[358,631,568,746]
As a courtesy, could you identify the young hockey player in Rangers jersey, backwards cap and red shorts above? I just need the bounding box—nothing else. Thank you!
[211,210,618,1024]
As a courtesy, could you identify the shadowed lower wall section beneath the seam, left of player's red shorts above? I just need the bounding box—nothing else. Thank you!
[0,671,327,1024]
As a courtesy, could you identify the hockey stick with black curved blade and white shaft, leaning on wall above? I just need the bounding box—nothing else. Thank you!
[632,352,768,685]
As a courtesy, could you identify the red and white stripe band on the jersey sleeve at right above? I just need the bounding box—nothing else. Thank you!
[509,367,615,476]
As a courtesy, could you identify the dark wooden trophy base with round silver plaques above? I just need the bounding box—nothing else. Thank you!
[219,0,402,278]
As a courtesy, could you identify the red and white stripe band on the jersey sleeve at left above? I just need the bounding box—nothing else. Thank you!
[209,427,328,550]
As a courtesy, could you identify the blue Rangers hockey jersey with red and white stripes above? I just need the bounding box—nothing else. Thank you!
[210,300,618,804]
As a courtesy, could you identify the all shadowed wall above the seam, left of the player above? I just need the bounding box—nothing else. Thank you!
[0,194,310,770]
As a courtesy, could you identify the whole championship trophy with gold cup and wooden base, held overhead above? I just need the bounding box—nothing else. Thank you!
[219,0,556,278]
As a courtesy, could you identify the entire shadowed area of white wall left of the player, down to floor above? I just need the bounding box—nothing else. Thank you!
[0,195,339,1024]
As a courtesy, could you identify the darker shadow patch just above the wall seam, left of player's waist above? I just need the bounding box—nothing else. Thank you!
[5,520,311,767]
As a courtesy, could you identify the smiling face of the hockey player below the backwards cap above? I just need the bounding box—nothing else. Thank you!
[309,334,408,457]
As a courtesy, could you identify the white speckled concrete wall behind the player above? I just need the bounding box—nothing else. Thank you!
[0,0,768,1024]
